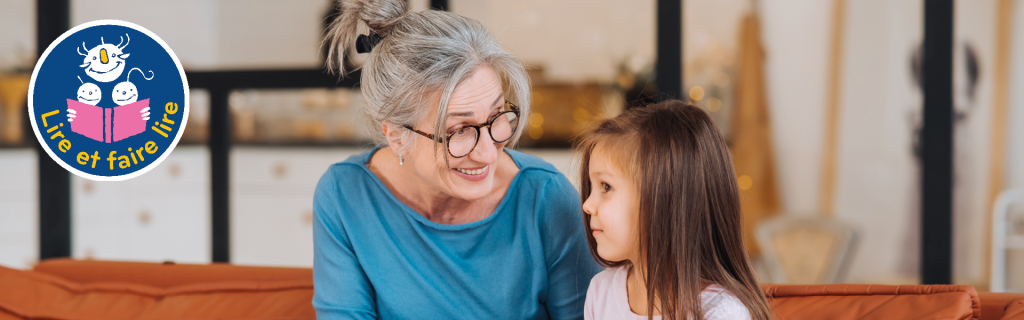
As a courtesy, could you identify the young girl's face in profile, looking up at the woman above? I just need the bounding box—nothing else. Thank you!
[583,144,640,263]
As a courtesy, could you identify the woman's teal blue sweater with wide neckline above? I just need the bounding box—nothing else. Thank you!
[312,149,601,319]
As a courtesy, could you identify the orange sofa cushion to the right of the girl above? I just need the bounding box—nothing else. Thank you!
[765,284,981,320]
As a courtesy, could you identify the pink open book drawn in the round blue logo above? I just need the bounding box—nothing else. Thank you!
[68,98,150,144]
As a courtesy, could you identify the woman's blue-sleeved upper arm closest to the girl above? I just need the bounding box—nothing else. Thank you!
[538,174,602,319]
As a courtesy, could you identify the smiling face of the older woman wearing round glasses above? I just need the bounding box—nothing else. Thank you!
[407,66,508,200]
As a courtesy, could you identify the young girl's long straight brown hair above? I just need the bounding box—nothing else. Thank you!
[575,101,774,320]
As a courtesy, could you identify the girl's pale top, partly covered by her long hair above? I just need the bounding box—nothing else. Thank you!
[583,267,751,320]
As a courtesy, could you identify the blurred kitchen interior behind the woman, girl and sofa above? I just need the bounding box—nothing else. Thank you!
[0,0,1024,290]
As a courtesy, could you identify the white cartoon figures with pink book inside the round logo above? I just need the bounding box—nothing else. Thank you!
[68,34,154,144]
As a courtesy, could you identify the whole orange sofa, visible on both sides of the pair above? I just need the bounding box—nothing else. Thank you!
[0,259,1024,320]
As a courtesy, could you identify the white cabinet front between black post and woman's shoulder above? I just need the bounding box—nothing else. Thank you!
[230,147,368,267]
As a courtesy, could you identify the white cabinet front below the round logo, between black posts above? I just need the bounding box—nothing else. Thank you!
[72,146,211,264]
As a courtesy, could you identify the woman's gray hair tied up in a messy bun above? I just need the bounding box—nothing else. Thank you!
[323,0,530,154]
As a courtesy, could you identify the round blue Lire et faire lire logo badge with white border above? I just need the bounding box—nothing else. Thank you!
[29,21,188,181]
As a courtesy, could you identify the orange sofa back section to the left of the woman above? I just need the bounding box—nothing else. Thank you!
[0,263,315,319]
